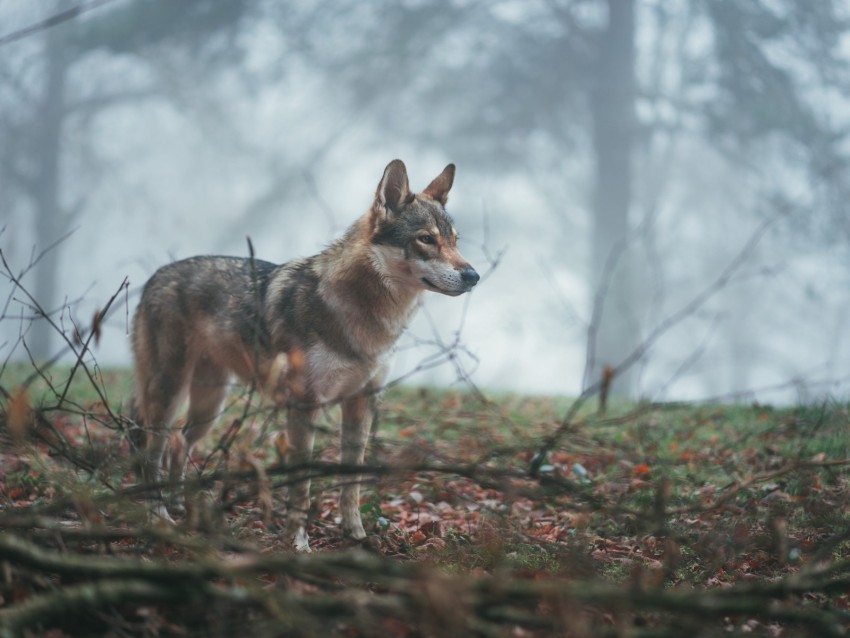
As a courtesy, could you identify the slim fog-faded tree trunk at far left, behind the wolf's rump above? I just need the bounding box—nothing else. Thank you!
[27,27,68,359]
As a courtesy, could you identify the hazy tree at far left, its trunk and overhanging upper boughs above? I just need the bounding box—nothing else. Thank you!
[0,0,250,359]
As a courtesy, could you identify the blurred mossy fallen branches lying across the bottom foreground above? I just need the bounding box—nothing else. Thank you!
[0,534,850,638]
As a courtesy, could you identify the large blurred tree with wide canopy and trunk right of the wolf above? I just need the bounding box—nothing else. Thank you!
[281,0,850,395]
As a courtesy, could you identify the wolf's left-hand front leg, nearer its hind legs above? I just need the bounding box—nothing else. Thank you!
[286,408,315,552]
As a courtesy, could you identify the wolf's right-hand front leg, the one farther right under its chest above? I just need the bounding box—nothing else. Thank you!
[339,396,373,540]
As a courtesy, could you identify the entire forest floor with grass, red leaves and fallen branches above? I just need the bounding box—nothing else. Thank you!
[0,366,850,638]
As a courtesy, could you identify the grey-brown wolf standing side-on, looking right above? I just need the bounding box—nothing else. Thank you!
[131,160,479,551]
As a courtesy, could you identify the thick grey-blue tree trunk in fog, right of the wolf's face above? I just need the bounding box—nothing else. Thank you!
[585,0,639,396]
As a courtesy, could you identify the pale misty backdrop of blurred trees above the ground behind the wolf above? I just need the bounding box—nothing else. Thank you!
[0,0,850,403]
